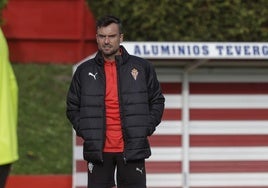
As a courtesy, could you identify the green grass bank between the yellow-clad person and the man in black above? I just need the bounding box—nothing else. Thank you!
[11,64,72,174]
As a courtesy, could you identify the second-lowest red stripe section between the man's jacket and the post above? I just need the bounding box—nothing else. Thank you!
[149,135,181,147]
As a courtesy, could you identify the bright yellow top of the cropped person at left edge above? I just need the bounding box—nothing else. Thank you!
[0,28,19,165]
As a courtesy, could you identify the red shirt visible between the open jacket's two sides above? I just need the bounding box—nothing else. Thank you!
[103,61,124,152]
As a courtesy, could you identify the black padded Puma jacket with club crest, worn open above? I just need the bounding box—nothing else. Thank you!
[66,46,165,162]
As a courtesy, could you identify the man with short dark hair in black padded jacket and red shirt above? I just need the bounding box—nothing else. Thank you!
[67,16,165,188]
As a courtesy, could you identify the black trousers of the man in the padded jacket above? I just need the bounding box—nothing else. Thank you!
[88,152,146,188]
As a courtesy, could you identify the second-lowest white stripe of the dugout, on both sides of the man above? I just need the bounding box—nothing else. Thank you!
[75,146,268,161]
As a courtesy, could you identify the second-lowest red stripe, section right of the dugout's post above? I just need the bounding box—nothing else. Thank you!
[190,135,268,147]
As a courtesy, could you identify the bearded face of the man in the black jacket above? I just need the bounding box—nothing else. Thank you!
[96,23,123,60]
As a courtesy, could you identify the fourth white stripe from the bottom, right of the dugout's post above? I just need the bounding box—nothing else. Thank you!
[189,94,268,109]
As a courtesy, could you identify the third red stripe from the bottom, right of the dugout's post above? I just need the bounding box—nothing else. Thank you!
[190,109,268,120]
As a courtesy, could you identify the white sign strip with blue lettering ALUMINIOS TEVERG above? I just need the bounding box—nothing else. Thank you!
[122,42,268,59]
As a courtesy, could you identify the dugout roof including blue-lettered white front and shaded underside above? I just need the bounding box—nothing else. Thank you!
[122,42,268,69]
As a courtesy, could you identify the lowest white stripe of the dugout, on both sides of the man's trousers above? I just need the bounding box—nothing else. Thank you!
[72,172,268,187]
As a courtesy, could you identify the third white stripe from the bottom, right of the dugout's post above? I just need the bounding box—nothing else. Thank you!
[188,121,268,136]
